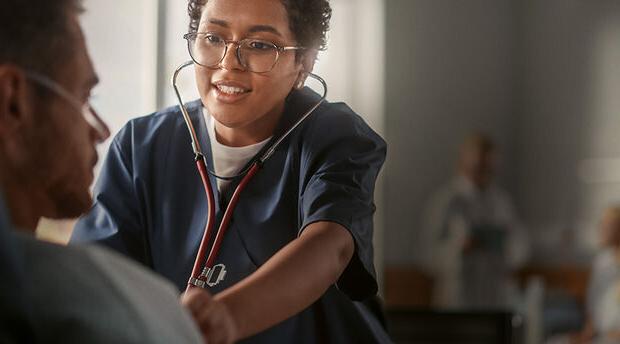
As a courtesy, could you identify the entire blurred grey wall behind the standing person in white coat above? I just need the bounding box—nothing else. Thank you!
[386,0,620,264]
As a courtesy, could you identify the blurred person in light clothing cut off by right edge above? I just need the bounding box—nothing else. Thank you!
[573,206,620,344]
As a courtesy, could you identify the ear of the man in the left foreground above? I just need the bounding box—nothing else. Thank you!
[0,65,28,135]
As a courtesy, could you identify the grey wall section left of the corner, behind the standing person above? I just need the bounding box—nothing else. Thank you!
[385,0,515,264]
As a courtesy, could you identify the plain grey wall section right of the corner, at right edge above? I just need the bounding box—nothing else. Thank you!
[516,0,620,262]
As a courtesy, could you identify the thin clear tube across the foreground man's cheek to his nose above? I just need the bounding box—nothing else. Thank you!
[25,71,110,141]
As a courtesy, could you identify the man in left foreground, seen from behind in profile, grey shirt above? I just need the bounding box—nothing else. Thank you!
[0,0,202,344]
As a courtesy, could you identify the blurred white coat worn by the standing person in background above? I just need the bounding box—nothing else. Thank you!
[424,177,529,309]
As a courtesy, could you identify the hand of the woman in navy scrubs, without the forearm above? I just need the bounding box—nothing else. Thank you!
[181,288,238,344]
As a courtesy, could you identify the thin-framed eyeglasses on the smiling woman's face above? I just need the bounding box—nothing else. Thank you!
[183,32,305,73]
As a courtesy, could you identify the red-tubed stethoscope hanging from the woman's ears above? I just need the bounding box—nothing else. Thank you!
[172,61,327,289]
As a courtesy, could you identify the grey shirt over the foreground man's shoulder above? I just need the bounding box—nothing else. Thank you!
[17,235,202,343]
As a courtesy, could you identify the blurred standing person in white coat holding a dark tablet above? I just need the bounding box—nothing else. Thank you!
[426,133,529,310]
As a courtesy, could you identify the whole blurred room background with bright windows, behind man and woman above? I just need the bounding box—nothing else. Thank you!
[38,0,620,343]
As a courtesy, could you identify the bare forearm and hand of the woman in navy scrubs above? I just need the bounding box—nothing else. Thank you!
[181,221,355,344]
